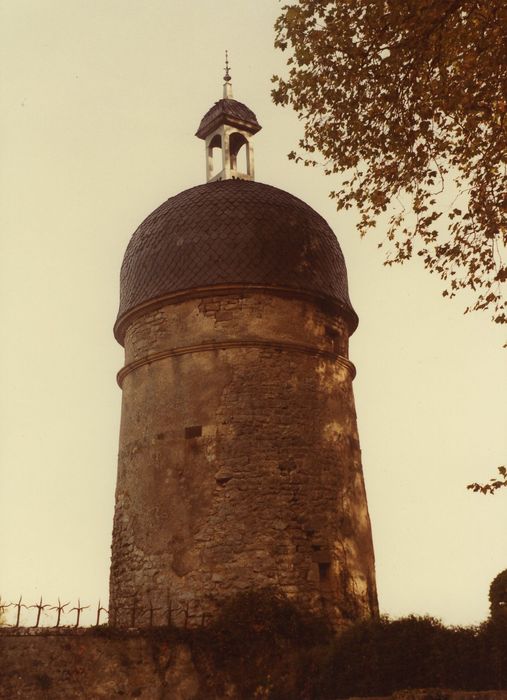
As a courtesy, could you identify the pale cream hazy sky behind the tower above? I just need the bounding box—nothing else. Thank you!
[0,0,507,625]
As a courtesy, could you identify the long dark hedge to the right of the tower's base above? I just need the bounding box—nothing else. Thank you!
[312,616,507,699]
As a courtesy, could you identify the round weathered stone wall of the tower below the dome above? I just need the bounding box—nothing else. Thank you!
[110,293,377,626]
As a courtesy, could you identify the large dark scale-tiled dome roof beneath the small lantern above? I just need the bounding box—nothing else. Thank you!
[115,180,357,342]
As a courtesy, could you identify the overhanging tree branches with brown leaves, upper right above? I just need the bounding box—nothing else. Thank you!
[272,0,507,323]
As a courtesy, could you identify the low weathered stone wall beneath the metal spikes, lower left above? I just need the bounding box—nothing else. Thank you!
[0,630,200,700]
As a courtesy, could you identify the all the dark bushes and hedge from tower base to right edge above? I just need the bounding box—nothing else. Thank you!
[162,592,507,700]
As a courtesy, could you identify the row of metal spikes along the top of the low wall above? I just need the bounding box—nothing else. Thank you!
[0,595,208,629]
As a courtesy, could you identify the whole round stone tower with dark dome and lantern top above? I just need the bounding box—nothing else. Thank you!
[110,71,377,626]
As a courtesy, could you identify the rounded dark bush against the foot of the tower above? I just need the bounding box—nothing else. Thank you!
[193,589,333,700]
